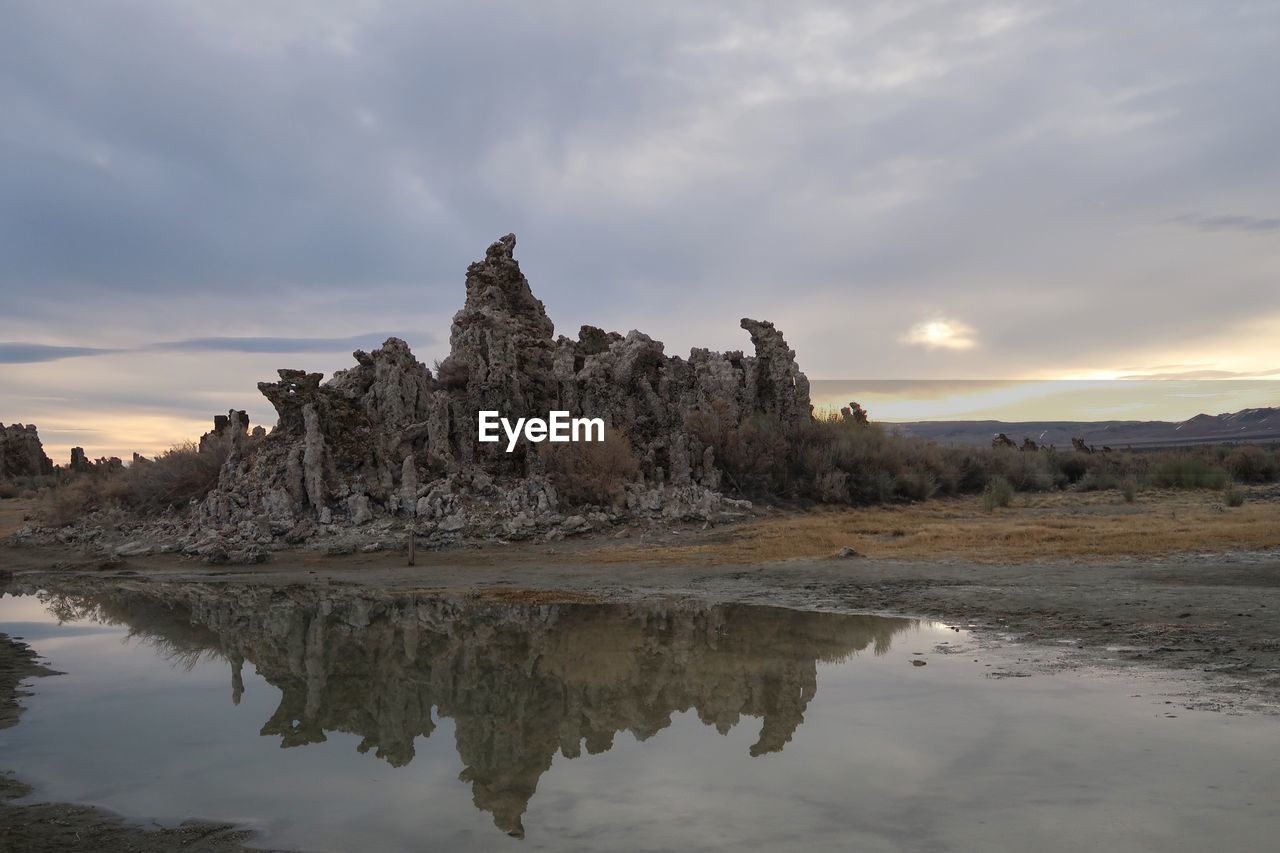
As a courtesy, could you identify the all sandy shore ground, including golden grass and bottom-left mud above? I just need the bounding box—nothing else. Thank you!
[0,492,1280,850]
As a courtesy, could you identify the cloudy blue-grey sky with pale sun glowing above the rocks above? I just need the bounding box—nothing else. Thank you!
[0,0,1280,461]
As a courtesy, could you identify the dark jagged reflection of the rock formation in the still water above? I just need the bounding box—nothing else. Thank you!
[37,584,913,835]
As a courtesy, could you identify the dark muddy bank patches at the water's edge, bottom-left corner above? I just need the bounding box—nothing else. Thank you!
[0,596,282,853]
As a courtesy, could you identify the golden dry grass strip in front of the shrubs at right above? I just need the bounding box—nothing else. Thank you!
[575,491,1280,565]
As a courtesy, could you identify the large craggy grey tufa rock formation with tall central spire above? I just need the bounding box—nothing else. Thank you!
[197,234,812,544]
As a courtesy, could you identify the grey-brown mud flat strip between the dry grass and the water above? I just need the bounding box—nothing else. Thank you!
[0,532,1280,712]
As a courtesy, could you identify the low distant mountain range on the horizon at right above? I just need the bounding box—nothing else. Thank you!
[886,409,1280,450]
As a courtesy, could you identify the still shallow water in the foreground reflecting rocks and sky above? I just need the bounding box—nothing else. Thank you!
[0,585,1280,853]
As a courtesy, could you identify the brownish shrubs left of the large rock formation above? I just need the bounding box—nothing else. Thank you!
[36,442,229,526]
